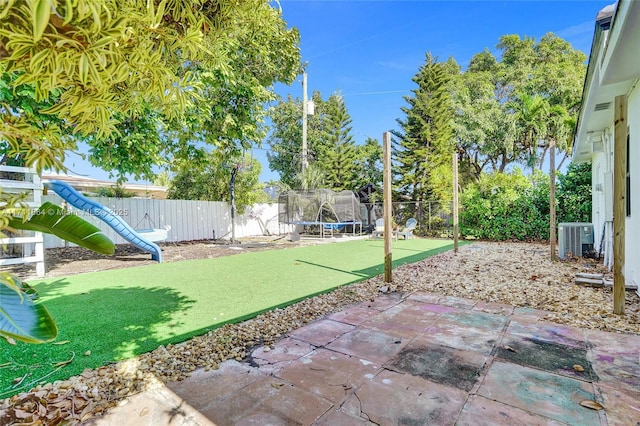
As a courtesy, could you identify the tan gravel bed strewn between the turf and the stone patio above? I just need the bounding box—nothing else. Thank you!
[0,242,640,425]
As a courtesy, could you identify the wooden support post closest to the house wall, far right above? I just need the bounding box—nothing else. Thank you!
[613,95,629,315]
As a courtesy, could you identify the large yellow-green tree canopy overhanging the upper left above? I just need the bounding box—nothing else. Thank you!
[0,0,299,176]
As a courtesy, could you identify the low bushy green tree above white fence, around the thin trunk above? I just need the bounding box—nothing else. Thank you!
[167,150,268,212]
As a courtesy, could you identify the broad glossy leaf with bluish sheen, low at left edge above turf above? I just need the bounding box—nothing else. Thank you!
[0,273,58,343]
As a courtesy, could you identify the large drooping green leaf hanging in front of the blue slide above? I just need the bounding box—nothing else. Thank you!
[9,202,115,254]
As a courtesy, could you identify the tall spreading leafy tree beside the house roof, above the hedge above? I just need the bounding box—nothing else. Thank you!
[453,33,586,176]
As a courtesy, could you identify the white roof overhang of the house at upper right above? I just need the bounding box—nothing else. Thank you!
[573,0,640,162]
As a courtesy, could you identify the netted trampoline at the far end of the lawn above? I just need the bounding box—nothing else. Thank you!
[278,189,362,238]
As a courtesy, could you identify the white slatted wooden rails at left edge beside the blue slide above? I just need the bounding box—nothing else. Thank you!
[0,166,44,276]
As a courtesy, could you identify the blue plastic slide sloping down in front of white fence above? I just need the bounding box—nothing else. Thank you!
[45,180,162,262]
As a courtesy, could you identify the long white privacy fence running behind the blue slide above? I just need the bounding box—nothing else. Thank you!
[42,192,286,248]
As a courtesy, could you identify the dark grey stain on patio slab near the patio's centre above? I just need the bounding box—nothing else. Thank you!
[390,346,484,391]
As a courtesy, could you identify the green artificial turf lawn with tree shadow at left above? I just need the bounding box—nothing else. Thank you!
[0,239,452,398]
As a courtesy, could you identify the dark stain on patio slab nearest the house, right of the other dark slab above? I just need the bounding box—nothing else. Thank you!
[497,338,599,382]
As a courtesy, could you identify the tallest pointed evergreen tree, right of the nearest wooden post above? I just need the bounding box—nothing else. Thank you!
[393,53,454,216]
